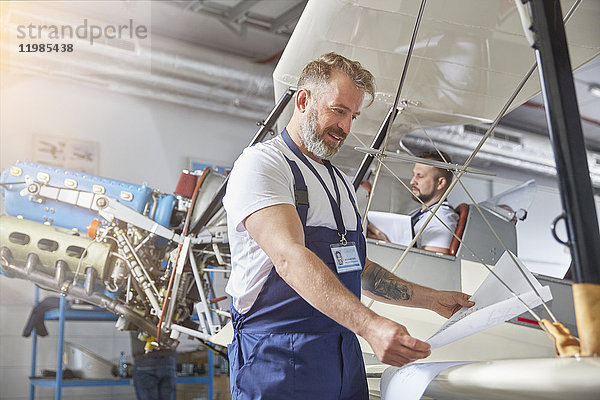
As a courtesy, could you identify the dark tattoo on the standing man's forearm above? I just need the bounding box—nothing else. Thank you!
[362,263,413,301]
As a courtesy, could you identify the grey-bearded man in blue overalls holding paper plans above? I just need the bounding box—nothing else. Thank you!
[223,53,473,399]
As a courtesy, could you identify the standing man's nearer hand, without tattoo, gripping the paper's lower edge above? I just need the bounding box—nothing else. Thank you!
[363,315,431,367]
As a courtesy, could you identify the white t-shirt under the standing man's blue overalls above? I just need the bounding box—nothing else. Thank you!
[223,135,357,313]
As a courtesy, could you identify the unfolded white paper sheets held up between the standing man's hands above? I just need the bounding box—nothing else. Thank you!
[427,252,552,349]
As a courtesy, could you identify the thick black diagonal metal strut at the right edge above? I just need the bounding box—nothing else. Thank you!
[530,0,600,284]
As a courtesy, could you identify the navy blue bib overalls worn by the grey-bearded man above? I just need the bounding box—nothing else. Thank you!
[228,131,369,400]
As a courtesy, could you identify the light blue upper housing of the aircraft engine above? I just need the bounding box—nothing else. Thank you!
[0,162,176,232]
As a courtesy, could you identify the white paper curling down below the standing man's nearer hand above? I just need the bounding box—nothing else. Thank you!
[380,361,469,400]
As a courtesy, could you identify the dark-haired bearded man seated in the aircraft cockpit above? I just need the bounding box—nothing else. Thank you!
[410,151,458,254]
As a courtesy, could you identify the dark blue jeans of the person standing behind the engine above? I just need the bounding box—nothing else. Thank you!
[133,357,177,400]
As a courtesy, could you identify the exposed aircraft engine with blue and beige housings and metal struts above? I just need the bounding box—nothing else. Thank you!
[0,162,229,344]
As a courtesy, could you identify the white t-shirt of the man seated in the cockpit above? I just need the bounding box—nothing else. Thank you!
[411,202,458,249]
